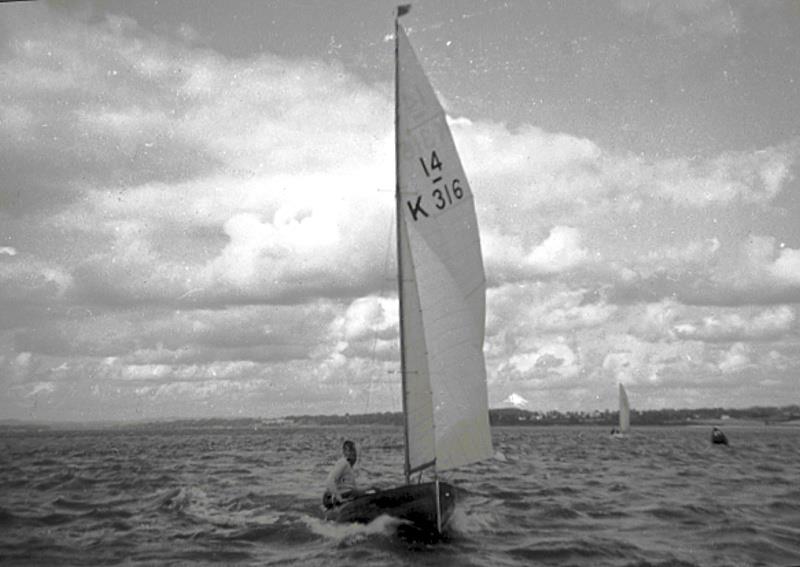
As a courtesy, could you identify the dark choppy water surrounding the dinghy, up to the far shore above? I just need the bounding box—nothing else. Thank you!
[0,426,800,567]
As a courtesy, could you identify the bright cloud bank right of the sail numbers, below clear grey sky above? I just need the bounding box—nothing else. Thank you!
[454,122,800,224]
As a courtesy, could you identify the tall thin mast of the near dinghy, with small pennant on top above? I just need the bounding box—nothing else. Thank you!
[394,5,411,484]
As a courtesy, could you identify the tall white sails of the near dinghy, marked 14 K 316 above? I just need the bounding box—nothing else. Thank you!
[397,26,492,471]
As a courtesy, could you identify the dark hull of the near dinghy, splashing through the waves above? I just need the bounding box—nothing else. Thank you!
[325,482,456,534]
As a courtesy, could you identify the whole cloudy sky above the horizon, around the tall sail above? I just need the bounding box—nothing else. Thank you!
[0,0,800,421]
